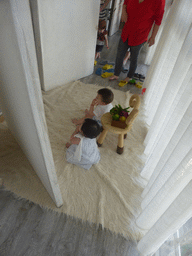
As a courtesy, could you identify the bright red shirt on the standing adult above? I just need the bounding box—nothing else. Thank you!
[121,0,165,46]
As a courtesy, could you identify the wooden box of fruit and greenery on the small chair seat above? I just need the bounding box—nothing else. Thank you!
[110,104,130,129]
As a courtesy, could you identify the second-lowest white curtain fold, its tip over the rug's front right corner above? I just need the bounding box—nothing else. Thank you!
[137,148,192,230]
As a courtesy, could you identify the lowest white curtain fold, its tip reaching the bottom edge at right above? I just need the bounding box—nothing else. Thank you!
[137,181,192,256]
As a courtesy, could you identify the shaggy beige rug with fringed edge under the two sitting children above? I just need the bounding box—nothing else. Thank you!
[0,81,147,239]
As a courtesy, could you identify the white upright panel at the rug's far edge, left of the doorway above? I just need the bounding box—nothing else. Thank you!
[30,0,100,91]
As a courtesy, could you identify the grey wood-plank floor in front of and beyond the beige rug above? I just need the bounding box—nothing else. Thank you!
[0,33,148,256]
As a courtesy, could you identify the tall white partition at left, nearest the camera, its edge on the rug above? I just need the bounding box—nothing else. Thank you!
[0,0,63,207]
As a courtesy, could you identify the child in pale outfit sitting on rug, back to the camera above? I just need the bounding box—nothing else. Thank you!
[66,118,101,170]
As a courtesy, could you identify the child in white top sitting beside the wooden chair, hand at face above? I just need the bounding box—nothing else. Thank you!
[72,88,114,126]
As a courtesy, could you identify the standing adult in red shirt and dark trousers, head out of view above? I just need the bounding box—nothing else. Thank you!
[109,0,165,85]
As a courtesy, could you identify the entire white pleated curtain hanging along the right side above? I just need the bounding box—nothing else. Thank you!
[136,0,192,255]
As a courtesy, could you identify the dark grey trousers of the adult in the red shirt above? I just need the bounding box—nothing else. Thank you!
[114,38,145,78]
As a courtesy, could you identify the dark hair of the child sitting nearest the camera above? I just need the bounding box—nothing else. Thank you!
[81,118,101,139]
